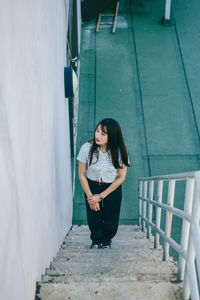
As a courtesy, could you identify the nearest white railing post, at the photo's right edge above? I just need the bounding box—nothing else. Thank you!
[183,172,200,300]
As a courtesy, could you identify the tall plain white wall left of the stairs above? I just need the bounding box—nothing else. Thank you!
[0,0,72,300]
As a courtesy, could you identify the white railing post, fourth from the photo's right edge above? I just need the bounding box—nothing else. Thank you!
[154,180,163,249]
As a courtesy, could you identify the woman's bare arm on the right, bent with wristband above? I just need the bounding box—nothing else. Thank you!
[88,166,127,203]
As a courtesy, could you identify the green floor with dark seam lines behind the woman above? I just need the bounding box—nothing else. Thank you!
[73,0,200,224]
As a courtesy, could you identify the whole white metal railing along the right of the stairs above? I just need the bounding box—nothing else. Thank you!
[139,171,200,300]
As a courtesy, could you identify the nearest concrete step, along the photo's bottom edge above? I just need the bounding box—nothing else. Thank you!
[40,281,182,300]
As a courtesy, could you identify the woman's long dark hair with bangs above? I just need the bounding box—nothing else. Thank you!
[89,119,130,169]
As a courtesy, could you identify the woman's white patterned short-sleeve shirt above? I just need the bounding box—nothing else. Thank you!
[77,142,123,183]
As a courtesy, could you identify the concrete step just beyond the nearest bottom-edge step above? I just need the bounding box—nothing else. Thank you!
[46,262,177,281]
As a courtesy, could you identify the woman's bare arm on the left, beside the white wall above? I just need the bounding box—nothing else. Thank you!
[78,161,100,210]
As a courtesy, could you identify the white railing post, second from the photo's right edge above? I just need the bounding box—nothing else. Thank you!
[178,178,195,281]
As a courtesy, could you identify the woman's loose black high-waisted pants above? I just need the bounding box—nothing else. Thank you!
[85,179,122,244]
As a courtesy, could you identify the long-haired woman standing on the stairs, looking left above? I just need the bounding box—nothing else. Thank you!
[77,119,129,249]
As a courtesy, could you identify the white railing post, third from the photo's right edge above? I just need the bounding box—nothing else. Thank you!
[163,179,176,260]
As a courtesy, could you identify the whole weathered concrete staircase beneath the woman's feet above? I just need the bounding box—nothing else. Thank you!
[36,225,182,300]
